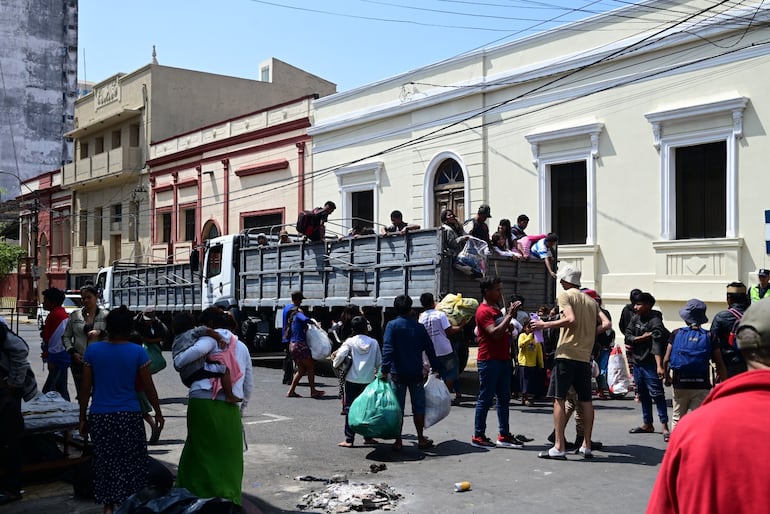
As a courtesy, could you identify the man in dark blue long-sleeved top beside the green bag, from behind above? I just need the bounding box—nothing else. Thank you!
[381,294,439,450]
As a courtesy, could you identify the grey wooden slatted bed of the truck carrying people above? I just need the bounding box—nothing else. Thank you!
[239,229,555,310]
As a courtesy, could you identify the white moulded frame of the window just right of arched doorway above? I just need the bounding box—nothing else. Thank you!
[525,123,604,245]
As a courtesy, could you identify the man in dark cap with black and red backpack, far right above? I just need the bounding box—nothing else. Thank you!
[711,282,749,378]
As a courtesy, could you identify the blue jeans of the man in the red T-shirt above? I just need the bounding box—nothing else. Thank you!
[473,360,512,436]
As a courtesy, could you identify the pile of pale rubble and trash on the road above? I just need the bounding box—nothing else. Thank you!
[297,482,402,514]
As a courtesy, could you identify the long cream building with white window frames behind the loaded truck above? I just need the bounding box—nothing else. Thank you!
[310,0,770,320]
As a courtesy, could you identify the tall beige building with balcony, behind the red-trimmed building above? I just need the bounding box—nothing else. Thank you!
[63,59,335,285]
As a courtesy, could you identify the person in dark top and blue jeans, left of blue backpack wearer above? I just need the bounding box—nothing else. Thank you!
[625,293,671,441]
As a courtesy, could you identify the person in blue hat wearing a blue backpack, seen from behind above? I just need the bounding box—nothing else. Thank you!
[663,298,727,430]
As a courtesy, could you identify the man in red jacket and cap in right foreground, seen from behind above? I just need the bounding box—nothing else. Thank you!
[647,298,770,514]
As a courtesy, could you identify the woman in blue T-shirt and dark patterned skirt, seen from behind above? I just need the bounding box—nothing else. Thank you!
[79,306,164,514]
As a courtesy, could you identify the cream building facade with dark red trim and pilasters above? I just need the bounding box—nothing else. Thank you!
[147,95,326,262]
